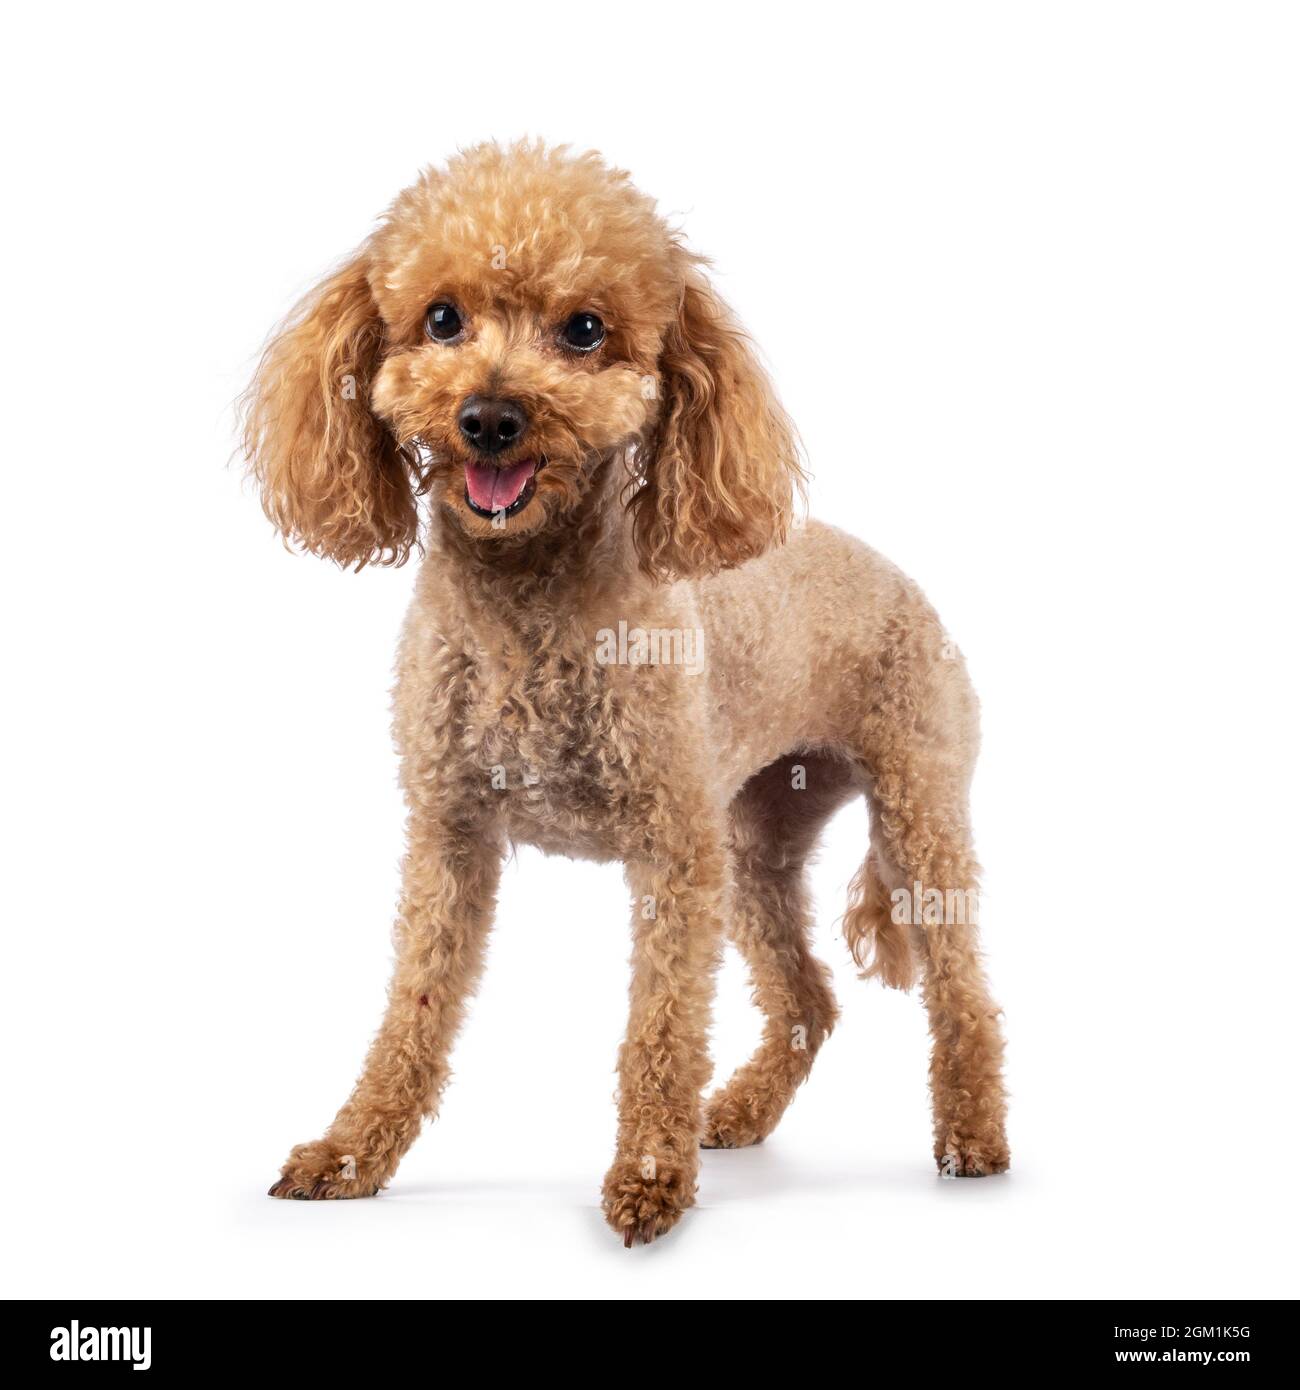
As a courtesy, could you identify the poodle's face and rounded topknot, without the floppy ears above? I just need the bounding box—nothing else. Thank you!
[371,147,685,541]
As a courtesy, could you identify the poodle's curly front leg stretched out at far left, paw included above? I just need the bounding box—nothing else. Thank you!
[271,830,501,1198]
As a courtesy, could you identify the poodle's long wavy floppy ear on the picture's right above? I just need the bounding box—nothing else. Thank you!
[630,267,804,577]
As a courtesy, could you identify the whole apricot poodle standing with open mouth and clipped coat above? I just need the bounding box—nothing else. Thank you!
[243,142,1008,1245]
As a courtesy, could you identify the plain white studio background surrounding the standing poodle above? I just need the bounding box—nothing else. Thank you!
[0,0,1300,1298]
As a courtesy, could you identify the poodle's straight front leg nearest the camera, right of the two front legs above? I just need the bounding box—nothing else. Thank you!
[603,817,726,1245]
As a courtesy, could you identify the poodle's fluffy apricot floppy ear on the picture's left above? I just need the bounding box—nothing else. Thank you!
[243,252,419,569]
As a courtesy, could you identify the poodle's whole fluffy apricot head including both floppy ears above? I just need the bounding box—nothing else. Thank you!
[245,145,799,575]
